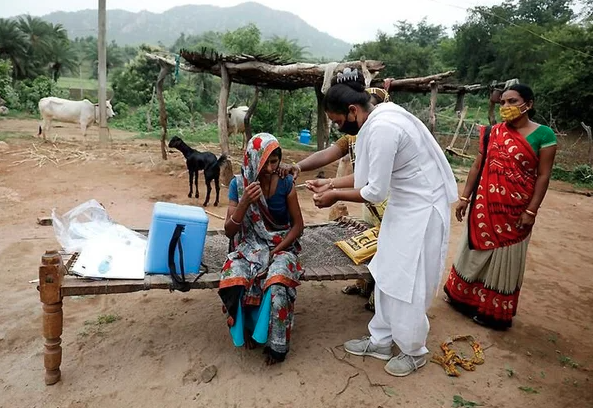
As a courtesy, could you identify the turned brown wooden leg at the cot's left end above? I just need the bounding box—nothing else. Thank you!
[39,251,64,385]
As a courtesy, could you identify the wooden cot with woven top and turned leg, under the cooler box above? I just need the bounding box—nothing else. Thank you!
[37,222,370,385]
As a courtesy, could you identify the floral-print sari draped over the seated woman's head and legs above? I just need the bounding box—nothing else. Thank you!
[219,133,302,361]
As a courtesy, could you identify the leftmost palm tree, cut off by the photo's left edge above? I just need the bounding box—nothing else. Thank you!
[0,18,29,78]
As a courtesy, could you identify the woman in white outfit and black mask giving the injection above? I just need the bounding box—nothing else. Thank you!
[307,69,457,376]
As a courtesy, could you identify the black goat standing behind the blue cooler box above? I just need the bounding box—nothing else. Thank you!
[169,136,227,207]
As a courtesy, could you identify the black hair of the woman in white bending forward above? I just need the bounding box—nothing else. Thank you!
[323,74,371,115]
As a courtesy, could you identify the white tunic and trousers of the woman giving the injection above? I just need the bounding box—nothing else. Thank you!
[354,103,457,355]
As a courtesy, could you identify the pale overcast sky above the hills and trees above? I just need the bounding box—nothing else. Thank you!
[0,0,502,43]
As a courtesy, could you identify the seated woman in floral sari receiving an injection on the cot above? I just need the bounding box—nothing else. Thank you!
[219,133,303,364]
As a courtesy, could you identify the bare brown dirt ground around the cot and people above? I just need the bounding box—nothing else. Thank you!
[0,120,593,408]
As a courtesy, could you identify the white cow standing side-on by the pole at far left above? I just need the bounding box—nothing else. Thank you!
[37,96,115,140]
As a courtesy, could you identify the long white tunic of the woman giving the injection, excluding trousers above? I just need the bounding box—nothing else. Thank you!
[354,103,457,303]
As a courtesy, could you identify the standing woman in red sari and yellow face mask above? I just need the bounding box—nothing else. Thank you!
[444,84,556,330]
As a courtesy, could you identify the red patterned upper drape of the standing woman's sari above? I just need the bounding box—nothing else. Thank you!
[468,123,539,250]
